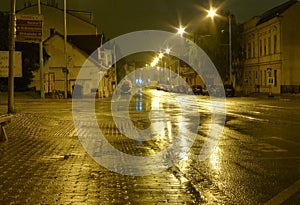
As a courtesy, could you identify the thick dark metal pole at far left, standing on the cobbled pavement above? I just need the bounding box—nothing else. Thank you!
[7,0,16,113]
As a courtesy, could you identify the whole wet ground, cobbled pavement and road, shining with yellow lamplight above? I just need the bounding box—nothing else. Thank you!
[0,90,300,205]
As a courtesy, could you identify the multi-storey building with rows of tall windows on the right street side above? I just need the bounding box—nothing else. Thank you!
[242,0,300,94]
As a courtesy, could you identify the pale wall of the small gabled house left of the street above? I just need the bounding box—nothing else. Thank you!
[31,35,99,94]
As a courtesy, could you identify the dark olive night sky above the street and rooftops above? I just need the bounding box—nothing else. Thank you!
[0,0,288,38]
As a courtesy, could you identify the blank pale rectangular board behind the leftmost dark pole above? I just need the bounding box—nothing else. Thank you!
[0,51,22,77]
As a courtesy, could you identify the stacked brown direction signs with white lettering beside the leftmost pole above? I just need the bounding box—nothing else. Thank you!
[16,14,44,43]
